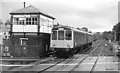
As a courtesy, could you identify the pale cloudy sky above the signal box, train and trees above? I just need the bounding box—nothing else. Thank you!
[0,0,119,32]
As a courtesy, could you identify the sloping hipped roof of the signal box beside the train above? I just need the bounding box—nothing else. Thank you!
[10,5,55,19]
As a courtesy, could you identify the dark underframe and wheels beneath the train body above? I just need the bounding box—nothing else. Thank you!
[54,42,92,58]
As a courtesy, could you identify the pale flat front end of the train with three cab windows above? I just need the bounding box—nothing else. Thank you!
[51,30,74,49]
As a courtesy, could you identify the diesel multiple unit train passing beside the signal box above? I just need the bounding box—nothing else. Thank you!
[51,26,94,57]
